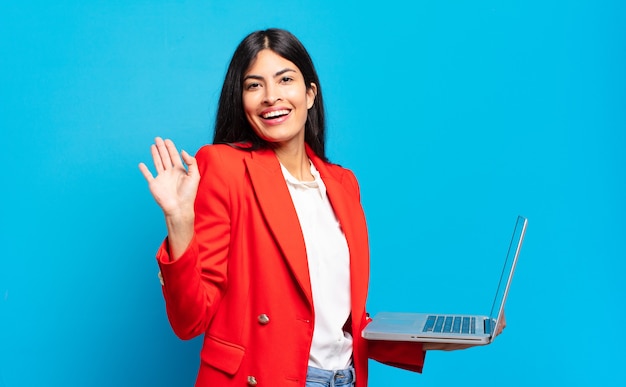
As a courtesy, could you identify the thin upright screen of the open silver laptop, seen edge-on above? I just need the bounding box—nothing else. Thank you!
[485,216,528,334]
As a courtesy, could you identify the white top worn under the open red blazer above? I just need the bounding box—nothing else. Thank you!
[281,163,352,370]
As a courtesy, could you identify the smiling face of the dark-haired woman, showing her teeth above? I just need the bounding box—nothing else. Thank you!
[242,49,317,152]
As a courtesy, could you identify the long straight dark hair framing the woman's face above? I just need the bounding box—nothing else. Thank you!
[213,28,327,160]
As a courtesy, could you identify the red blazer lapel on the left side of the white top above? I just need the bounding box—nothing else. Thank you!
[245,149,313,305]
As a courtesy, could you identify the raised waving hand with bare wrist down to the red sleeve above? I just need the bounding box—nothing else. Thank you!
[139,137,200,258]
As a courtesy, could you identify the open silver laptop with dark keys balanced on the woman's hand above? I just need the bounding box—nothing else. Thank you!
[362,216,528,345]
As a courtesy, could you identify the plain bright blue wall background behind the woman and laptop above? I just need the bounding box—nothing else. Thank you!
[0,0,626,387]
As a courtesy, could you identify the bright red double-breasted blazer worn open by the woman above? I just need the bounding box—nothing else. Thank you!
[157,145,424,387]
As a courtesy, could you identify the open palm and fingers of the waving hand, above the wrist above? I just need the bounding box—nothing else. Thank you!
[139,138,200,216]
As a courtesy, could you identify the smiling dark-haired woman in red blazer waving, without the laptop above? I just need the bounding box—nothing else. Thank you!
[140,29,470,387]
